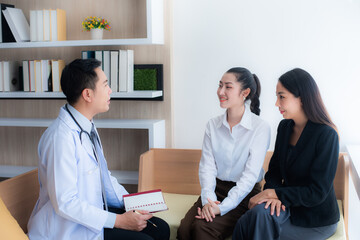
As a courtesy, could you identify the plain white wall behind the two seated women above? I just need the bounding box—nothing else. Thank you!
[173,0,360,148]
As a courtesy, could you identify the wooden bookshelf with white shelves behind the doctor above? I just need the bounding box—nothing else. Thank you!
[0,0,172,182]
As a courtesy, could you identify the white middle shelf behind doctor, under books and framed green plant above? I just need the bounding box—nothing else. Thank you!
[0,90,163,99]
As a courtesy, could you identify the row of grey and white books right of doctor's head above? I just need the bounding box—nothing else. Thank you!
[81,50,134,92]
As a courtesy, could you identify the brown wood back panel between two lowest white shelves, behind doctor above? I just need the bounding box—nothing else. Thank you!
[0,127,149,171]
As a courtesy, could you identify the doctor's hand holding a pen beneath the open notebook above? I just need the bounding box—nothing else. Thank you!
[114,210,153,232]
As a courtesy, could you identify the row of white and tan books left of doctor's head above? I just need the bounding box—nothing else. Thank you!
[22,60,65,92]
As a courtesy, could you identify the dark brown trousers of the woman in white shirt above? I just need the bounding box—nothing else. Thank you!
[177,179,261,240]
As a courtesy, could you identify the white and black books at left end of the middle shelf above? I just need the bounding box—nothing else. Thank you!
[0,61,21,92]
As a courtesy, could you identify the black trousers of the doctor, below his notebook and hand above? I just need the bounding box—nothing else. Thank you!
[104,208,170,240]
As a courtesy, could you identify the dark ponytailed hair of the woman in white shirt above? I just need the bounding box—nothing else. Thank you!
[226,67,261,115]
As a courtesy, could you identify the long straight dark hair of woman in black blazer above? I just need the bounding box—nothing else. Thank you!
[279,68,337,131]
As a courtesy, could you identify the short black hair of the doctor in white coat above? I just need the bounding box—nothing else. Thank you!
[60,59,101,105]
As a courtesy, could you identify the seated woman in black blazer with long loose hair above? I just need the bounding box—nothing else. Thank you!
[233,68,339,240]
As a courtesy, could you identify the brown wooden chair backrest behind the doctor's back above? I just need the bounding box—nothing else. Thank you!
[0,169,40,233]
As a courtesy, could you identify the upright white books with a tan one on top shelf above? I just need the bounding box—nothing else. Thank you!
[30,9,66,42]
